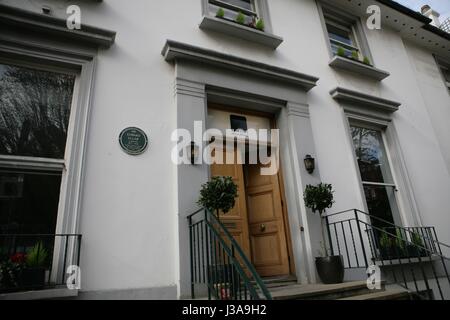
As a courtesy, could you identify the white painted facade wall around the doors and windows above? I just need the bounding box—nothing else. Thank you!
[5,0,450,290]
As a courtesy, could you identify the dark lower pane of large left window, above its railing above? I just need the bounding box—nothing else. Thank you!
[0,169,61,234]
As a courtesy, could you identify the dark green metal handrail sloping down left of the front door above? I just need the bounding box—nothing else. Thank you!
[187,208,272,300]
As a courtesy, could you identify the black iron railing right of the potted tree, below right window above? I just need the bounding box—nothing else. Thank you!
[324,209,450,300]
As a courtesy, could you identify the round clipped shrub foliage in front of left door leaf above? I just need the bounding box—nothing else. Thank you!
[197,177,238,215]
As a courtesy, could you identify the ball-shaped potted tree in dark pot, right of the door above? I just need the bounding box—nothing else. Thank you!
[303,183,344,284]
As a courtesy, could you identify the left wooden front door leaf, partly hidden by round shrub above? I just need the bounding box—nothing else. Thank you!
[211,148,250,257]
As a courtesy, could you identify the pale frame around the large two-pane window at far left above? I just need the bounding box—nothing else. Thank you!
[0,40,97,242]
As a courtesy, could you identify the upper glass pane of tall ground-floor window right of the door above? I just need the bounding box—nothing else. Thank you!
[351,127,393,183]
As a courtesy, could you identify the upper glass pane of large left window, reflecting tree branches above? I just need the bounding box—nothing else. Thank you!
[0,64,75,159]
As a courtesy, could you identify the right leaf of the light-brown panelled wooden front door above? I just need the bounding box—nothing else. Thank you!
[245,164,289,277]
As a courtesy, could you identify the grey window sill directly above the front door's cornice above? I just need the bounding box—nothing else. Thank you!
[199,16,283,49]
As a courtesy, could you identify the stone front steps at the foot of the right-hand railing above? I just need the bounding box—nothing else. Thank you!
[267,281,410,300]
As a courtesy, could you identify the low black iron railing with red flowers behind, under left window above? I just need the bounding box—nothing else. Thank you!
[0,234,81,293]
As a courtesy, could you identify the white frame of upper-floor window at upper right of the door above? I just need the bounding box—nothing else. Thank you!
[317,1,374,64]
